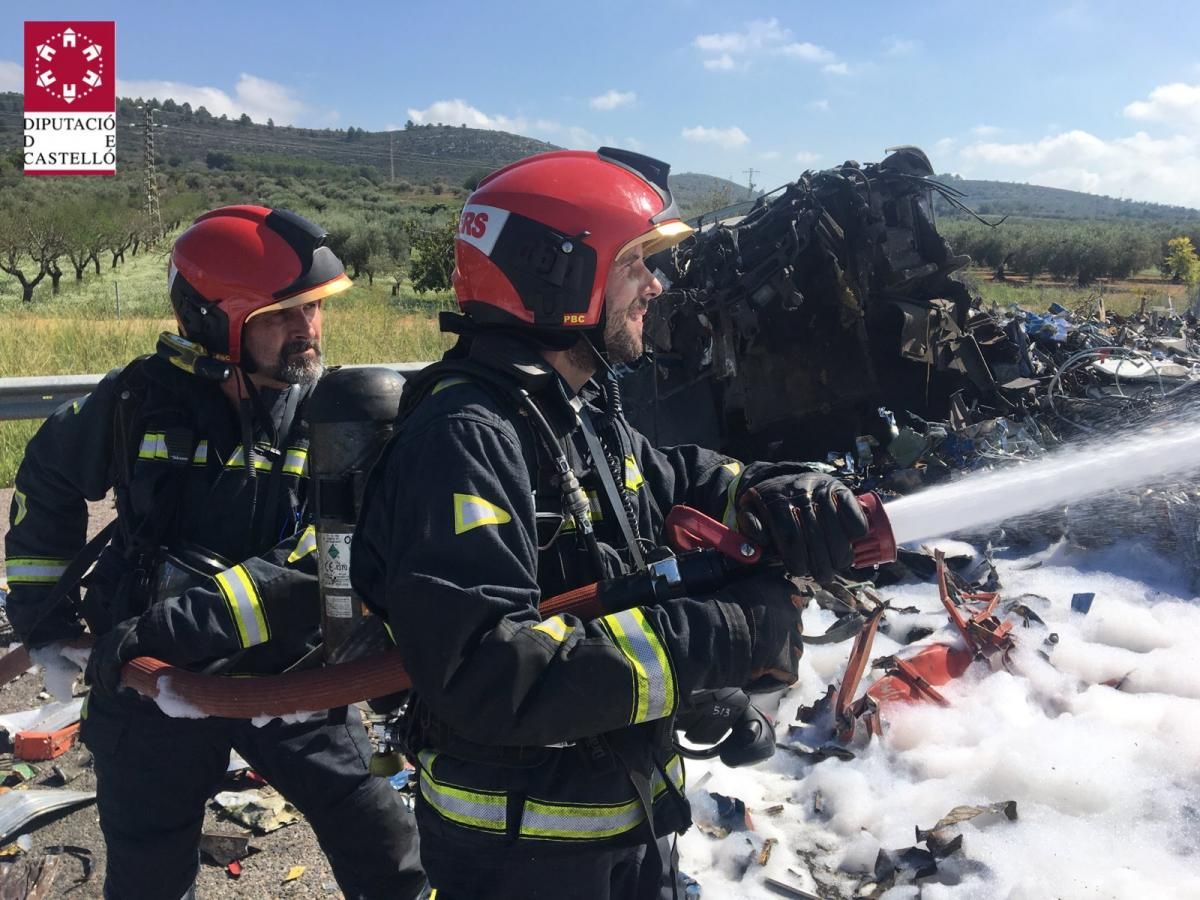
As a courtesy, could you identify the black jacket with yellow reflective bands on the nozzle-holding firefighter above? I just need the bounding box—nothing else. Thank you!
[352,337,772,842]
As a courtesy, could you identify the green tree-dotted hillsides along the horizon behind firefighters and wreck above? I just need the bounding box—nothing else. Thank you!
[0,88,1200,306]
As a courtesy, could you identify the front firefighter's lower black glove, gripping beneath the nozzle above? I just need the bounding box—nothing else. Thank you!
[721,572,804,694]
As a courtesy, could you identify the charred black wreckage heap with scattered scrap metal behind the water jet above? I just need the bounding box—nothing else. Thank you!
[623,148,1200,572]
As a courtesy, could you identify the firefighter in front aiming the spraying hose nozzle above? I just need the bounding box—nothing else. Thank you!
[352,149,866,900]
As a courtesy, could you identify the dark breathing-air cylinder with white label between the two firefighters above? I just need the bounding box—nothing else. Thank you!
[306,366,404,660]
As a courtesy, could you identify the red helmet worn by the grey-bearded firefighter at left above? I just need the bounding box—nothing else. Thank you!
[167,206,350,362]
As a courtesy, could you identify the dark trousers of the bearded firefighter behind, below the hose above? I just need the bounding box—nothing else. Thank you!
[80,695,425,900]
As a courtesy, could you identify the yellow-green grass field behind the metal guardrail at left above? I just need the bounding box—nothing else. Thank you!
[0,247,454,487]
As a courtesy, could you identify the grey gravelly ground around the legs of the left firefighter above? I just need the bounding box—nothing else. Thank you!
[0,488,369,900]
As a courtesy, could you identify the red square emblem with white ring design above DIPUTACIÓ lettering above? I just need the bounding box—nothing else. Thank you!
[25,22,116,113]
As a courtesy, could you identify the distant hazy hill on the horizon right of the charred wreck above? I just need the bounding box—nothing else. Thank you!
[934,175,1200,222]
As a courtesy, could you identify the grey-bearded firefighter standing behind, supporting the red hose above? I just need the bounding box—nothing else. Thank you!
[5,206,425,900]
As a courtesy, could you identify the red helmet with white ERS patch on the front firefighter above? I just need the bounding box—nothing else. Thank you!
[454,148,692,330]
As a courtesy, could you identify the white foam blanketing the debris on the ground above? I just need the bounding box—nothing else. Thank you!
[679,545,1200,900]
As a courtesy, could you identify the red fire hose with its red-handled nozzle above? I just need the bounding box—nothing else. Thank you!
[0,493,896,719]
